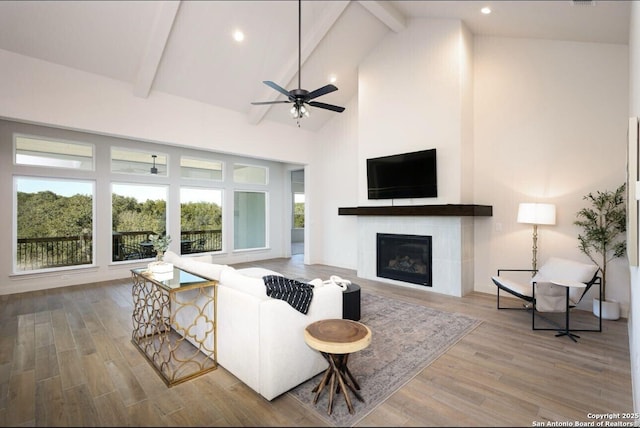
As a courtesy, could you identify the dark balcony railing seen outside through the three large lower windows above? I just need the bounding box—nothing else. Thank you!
[16,230,222,271]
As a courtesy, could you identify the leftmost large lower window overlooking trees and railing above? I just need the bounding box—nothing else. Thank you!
[14,177,95,272]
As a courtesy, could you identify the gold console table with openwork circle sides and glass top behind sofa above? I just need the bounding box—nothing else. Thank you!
[131,268,218,387]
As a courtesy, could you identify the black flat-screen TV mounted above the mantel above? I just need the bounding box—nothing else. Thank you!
[367,149,438,199]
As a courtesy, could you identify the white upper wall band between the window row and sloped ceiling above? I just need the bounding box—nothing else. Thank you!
[0,50,314,163]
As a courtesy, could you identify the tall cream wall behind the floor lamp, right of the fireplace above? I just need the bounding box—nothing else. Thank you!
[474,37,629,316]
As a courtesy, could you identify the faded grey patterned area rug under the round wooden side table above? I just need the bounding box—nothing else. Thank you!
[288,292,481,427]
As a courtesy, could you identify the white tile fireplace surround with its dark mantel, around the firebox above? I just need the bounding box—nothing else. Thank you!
[338,205,492,297]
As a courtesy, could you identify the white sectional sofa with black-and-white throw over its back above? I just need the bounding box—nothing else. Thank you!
[164,251,342,400]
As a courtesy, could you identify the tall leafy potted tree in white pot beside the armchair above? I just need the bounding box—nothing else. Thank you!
[574,184,627,320]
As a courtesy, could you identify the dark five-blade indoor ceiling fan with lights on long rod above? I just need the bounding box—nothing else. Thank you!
[251,0,344,127]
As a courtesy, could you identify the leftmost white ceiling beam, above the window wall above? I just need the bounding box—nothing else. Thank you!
[133,0,180,98]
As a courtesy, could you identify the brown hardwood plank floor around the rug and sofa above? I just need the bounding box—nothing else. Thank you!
[0,256,633,427]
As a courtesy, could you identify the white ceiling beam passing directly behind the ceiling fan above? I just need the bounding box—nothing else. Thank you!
[248,0,350,125]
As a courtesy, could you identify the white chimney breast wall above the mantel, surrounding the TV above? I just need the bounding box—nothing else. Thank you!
[358,19,471,205]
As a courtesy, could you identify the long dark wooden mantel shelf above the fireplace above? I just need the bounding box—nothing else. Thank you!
[338,204,493,217]
